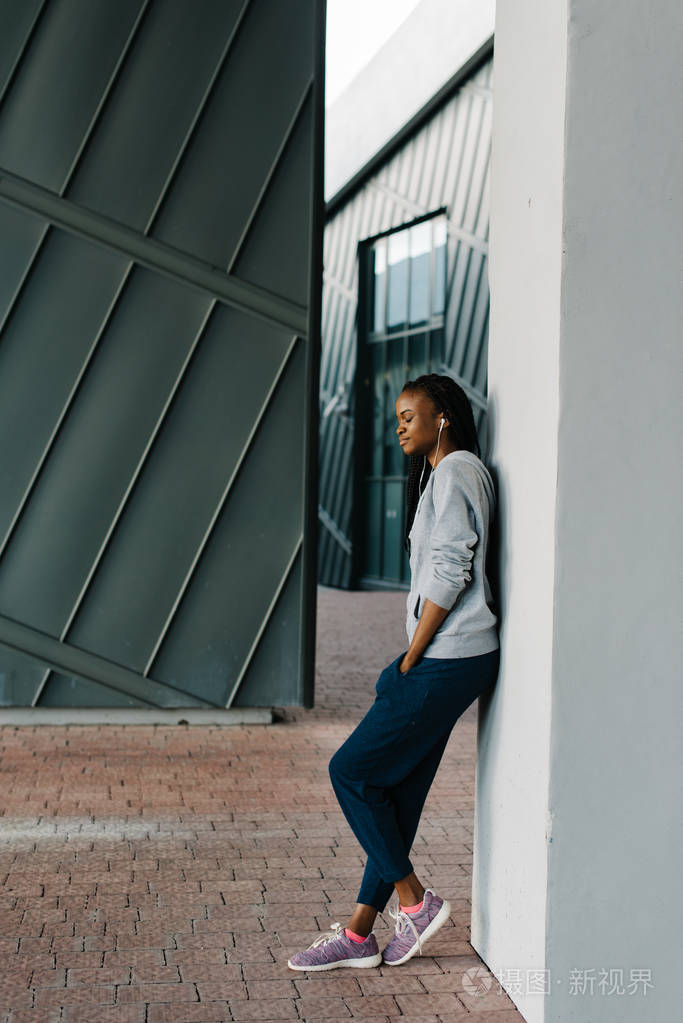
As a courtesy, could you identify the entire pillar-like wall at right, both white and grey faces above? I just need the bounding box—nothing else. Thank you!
[480,0,683,1023]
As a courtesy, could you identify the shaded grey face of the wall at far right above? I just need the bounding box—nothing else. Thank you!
[548,0,683,1023]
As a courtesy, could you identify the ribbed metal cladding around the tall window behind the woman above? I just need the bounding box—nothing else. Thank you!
[318,59,493,587]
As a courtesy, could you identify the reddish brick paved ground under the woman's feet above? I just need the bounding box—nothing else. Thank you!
[0,587,521,1023]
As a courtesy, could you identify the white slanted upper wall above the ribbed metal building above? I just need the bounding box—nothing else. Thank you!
[325,0,496,199]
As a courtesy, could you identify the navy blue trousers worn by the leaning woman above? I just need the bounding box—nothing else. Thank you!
[328,650,500,913]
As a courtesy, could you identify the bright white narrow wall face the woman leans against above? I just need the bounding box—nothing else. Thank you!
[471,0,566,1021]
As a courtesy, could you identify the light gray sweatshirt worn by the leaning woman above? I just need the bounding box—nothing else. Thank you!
[406,450,499,658]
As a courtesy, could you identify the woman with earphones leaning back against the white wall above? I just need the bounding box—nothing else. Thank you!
[287,373,500,971]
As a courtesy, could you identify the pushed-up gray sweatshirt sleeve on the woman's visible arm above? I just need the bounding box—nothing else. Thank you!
[421,466,479,610]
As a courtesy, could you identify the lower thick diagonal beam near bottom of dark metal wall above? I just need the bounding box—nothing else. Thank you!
[0,615,219,707]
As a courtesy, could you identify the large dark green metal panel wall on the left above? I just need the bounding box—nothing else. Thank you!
[0,0,324,707]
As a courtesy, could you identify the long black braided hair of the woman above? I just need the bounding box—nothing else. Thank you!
[402,373,482,554]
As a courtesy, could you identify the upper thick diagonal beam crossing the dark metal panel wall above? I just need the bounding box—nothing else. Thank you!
[0,168,308,339]
